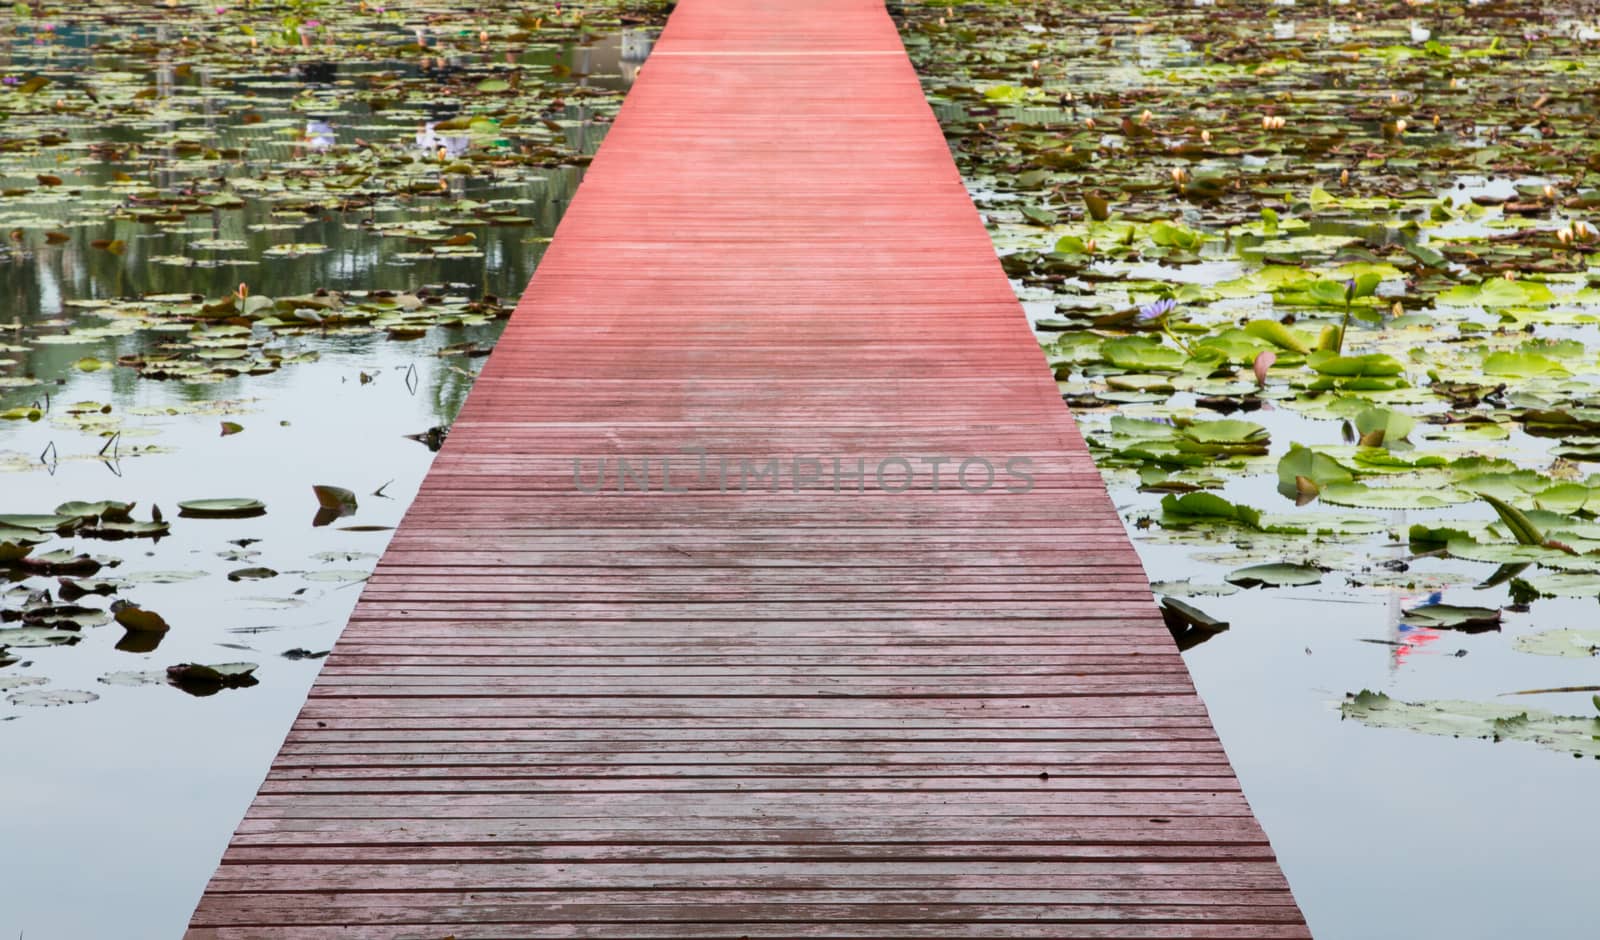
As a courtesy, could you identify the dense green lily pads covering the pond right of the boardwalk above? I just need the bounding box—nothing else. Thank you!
[899,0,1600,758]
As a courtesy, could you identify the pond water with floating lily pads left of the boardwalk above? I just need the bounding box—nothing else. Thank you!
[0,12,653,938]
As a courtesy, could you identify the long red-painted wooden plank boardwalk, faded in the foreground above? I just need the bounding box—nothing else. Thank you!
[190,0,1307,940]
